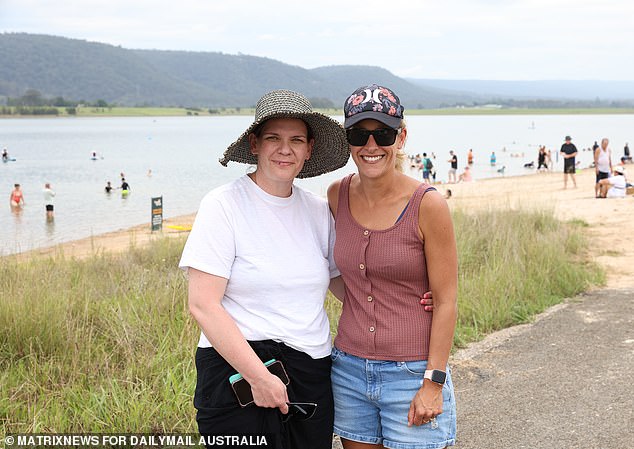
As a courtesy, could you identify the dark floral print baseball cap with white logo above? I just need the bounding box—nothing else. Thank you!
[343,84,405,129]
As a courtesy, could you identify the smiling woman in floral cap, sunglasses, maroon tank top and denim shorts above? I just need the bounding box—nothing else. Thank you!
[328,84,457,449]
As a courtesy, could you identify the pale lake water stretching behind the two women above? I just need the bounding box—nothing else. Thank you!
[0,115,634,255]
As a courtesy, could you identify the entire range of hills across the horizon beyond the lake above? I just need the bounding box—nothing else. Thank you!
[0,33,634,109]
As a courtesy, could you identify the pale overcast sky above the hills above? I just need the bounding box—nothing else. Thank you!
[0,0,634,80]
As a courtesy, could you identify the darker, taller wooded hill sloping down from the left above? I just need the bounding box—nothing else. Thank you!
[0,33,470,109]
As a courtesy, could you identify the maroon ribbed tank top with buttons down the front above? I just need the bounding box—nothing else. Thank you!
[334,175,433,362]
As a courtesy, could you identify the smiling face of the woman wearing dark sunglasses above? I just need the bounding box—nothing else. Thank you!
[350,119,407,177]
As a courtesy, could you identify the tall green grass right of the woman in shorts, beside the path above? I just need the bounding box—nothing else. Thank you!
[446,211,605,347]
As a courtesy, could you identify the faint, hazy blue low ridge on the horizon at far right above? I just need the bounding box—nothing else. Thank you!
[408,79,634,100]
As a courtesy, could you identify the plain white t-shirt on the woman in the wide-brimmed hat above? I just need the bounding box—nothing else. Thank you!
[179,175,339,358]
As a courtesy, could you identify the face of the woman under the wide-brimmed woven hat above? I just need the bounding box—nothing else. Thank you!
[249,118,314,195]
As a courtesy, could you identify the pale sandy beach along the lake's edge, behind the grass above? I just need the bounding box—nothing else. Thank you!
[18,166,634,288]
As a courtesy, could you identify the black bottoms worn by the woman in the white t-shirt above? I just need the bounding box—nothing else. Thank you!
[194,340,334,449]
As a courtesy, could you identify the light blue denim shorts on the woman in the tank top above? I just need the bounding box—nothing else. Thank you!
[331,348,456,449]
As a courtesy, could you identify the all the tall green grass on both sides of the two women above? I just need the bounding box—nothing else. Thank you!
[0,211,603,433]
